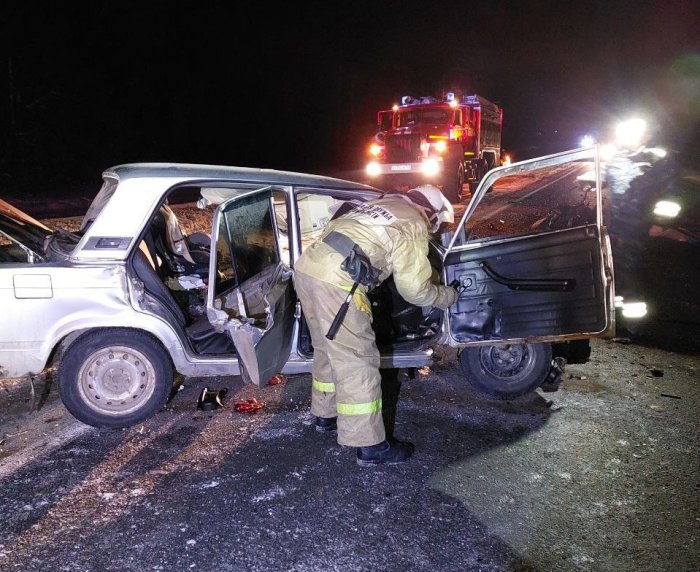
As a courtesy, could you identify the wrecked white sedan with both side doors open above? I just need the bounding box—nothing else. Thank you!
[0,149,614,427]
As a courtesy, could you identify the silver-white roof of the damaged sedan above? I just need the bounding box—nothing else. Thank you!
[103,163,377,191]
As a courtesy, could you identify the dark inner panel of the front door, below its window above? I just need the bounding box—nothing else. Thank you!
[445,223,608,342]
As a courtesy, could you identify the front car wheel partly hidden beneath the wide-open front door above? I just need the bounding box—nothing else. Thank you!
[459,344,552,399]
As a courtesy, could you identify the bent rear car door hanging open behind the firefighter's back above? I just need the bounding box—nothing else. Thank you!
[207,187,296,385]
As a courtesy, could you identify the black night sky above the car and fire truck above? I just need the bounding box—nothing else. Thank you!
[0,0,700,196]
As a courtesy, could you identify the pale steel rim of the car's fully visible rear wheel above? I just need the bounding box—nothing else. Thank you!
[78,346,156,416]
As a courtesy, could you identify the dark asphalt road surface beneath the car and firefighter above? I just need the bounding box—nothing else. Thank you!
[0,341,700,572]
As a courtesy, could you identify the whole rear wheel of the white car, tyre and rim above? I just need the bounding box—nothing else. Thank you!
[57,329,173,428]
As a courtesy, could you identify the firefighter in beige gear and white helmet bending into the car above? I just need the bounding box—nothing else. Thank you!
[294,185,457,466]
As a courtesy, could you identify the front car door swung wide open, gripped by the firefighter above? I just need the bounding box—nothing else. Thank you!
[443,148,614,346]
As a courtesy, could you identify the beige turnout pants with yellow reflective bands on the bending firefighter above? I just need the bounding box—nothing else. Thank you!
[294,271,386,447]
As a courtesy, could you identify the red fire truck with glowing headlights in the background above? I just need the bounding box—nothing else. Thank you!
[366,92,503,203]
